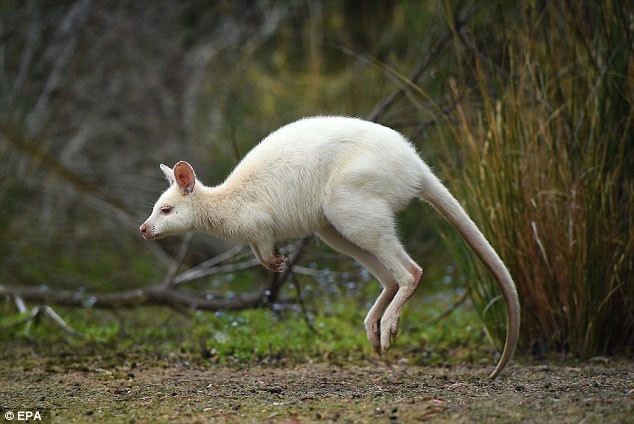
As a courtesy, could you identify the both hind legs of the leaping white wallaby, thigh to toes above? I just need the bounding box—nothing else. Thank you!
[325,196,422,352]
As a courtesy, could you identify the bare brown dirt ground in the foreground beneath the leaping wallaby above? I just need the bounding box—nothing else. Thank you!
[0,357,634,424]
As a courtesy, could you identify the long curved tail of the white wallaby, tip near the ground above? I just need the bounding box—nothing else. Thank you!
[419,171,520,379]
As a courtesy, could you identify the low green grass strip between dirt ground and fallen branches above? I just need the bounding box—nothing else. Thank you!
[0,293,493,366]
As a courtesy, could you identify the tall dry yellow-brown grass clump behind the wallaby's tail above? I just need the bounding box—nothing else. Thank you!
[434,1,634,356]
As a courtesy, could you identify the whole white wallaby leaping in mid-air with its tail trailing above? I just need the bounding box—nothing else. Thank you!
[140,117,520,378]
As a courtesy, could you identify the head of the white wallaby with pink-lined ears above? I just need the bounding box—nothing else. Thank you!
[139,161,201,240]
